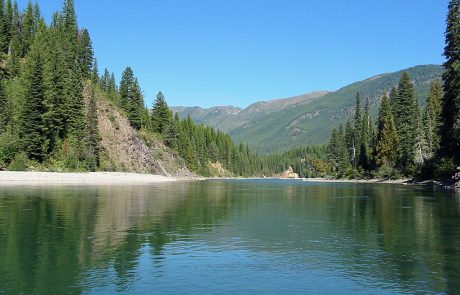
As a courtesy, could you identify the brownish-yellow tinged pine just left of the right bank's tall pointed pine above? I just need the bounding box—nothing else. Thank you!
[376,94,398,168]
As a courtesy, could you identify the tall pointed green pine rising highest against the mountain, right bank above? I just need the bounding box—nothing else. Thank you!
[394,72,419,176]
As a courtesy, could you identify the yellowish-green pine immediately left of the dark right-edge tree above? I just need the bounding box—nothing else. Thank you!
[423,80,442,159]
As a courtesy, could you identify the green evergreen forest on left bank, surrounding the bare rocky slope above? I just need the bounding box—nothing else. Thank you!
[0,0,328,176]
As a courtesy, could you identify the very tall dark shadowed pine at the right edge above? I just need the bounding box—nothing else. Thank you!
[441,0,460,165]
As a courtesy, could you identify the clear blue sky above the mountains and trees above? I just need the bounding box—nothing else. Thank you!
[18,0,448,107]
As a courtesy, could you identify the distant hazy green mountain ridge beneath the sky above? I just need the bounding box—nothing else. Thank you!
[173,65,443,152]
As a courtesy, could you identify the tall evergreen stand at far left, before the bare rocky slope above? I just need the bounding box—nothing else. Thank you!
[0,0,99,170]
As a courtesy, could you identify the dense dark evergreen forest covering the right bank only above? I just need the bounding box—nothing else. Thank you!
[327,0,460,180]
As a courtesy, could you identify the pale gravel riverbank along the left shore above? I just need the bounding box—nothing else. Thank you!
[0,171,177,185]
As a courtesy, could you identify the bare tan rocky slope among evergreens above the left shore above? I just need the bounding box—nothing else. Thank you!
[84,87,193,177]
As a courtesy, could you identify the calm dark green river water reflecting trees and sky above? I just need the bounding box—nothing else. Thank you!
[0,181,460,294]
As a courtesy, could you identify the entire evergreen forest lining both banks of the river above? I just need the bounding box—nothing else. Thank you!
[0,0,460,179]
